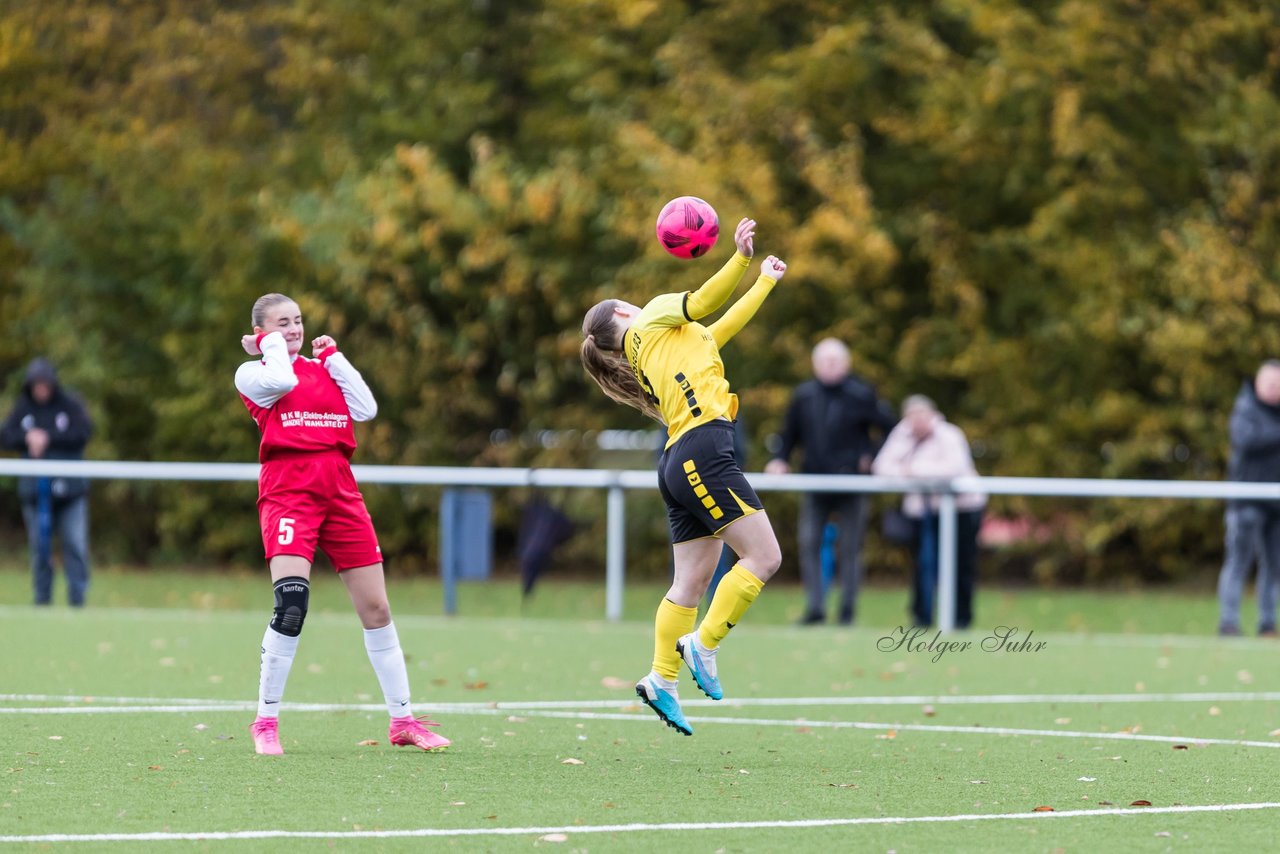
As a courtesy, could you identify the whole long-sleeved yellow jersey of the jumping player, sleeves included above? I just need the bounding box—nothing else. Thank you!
[623,254,776,447]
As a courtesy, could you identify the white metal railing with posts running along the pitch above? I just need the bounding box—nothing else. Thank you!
[0,458,1280,631]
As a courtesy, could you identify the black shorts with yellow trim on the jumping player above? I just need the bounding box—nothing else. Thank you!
[658,420,764,544]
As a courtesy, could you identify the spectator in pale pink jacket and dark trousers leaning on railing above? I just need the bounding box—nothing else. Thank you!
[872,394,987,629]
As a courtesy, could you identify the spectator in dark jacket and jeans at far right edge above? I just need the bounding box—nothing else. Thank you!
[1217,359,1280,636]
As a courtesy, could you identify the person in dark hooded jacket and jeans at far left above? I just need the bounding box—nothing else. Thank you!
[0,359,93,607]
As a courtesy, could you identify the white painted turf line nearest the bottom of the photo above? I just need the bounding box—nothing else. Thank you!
[0,803,1280,842]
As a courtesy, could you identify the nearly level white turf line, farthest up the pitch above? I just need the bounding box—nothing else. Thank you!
[0,691,1280,713]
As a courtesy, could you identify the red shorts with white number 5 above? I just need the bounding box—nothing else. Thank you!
[257,453,383,572]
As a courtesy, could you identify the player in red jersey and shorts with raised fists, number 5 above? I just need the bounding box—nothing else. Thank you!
[236,293,449,754]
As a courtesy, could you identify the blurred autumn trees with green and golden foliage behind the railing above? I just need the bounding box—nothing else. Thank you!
[0,0,1280,579]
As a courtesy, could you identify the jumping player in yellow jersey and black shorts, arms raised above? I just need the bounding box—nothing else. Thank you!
[582,219,787,735]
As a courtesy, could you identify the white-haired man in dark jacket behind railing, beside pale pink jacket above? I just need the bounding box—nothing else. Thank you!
[764,338,897,626]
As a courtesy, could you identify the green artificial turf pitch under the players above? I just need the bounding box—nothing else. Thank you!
[0,563,1280,851]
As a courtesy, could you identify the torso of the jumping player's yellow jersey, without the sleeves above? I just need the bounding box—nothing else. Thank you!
[626,291,737,447]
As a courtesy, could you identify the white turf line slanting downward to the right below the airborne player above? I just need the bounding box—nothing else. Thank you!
[0,702,1280,748]
